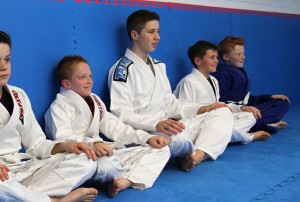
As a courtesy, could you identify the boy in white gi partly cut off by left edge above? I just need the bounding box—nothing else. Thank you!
[0,31,98,202]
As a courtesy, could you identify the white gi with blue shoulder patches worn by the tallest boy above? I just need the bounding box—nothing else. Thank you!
[108,49,233,159]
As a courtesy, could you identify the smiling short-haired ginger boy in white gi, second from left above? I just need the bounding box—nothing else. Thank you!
[45,56,170,197]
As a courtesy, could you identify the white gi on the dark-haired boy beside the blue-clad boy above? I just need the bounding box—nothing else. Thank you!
[174,68,256,144]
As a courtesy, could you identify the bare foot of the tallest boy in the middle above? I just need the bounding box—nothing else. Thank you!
[178,149,205,172]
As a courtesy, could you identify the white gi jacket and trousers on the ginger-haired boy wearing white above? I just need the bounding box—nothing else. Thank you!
[45,87,170,189]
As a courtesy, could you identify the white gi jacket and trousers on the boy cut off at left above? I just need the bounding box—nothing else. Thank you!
[0,85,96,201]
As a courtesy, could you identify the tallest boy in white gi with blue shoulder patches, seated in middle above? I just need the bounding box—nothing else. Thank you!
[108,10,233,171]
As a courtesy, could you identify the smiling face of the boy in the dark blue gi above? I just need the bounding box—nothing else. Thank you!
[223,45,246,68]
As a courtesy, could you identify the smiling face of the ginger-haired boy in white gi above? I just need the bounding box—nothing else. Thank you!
[62,62,93,98]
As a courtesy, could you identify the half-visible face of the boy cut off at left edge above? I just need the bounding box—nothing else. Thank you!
[0,43,11,89]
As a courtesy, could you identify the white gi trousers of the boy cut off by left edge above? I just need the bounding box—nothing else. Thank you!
[0,154,97,202]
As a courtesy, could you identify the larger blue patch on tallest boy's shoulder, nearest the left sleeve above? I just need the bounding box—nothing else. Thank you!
[113,56,133,83]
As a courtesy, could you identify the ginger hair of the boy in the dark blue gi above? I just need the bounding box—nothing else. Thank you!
[219,36,245,58]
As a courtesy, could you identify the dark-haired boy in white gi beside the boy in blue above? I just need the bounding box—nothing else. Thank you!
[174,41,270,144]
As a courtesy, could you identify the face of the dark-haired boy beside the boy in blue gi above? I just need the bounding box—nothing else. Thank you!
[195,49,219,77]
